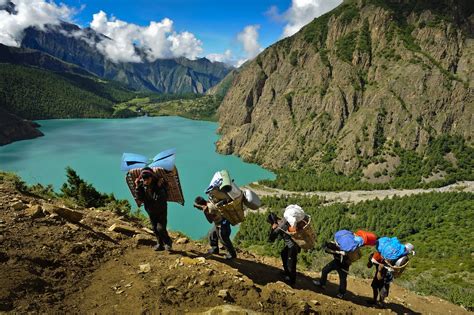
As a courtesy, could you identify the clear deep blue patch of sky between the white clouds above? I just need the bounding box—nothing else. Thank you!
[62,0,291,55]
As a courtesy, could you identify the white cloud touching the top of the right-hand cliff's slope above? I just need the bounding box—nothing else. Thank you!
[278,0,342,37]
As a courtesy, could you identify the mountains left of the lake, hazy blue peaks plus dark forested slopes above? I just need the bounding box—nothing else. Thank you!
[0,2,232,145]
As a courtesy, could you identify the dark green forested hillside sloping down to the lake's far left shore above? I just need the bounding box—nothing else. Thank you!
[0,64,136,119]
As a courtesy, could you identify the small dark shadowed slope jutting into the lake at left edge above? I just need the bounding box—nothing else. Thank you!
[0,107,43,145]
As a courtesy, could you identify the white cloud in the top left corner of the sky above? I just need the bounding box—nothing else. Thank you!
[0,0,76,47]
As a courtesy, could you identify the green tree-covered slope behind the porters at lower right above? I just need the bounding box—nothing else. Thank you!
[235,192,474,309]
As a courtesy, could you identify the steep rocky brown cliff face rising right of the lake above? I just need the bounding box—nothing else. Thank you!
[217,0,474,174]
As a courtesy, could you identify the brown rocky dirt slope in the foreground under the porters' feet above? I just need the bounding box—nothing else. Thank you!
[0,183,467,314]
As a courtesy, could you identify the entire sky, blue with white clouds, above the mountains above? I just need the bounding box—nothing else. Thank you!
[0,0,342,66]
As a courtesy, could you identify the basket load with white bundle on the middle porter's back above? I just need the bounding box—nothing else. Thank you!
[283,205,316,250]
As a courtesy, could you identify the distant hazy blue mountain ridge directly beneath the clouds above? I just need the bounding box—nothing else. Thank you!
[21,23,231,93]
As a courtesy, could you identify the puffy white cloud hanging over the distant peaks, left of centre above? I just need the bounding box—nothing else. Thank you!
[90,11,202,62]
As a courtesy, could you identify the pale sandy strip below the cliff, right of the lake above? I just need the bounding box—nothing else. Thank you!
[246,181,474,204]
